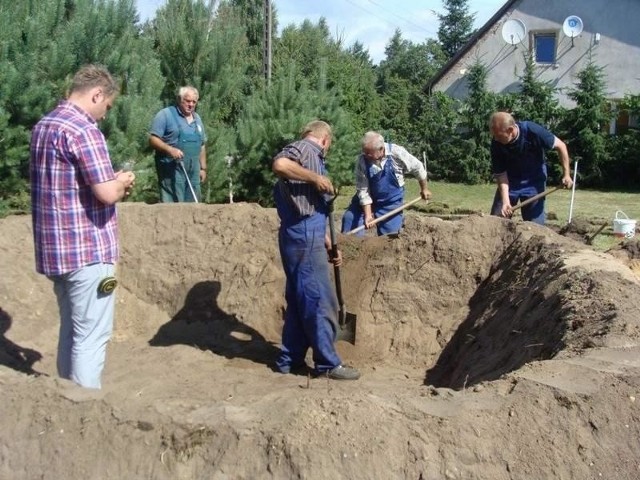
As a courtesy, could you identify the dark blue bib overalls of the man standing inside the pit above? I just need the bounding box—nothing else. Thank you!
[274,170,341,373]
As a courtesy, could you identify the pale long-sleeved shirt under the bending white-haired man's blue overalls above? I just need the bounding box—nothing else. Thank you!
[355,143,427,205]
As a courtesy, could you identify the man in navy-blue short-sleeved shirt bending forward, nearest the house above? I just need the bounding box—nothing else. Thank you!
[489,112,573,225]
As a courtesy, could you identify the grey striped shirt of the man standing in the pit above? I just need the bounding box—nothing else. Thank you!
[273,139,327,217]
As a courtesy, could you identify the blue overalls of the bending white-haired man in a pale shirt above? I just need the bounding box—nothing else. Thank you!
[342,144,404,235]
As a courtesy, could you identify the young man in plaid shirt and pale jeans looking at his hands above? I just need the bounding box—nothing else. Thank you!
[30,65,135,388]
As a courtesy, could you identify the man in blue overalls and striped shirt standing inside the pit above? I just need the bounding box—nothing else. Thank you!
[272,120,360,380]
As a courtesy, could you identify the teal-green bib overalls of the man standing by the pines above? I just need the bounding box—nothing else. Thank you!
[156,107,202,202]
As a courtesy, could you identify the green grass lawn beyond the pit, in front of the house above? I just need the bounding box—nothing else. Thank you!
[336,179,640,250]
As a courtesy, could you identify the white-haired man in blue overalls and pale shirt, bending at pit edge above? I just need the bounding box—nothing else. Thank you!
[342,132,431,235]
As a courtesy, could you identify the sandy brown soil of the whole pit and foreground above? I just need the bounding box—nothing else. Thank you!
[0,203,640,480]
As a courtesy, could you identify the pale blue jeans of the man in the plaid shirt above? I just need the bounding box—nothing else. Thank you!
[49,263,115,388]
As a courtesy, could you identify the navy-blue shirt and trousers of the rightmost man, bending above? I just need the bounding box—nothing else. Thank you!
[491,121,555,225]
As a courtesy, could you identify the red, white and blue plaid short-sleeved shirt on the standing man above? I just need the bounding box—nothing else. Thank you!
[29,101,118,275]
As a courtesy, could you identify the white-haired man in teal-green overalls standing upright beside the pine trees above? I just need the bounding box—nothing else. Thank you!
[149,86,207,202]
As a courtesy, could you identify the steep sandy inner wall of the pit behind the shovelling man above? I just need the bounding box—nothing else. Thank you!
[109,205,636,389]
